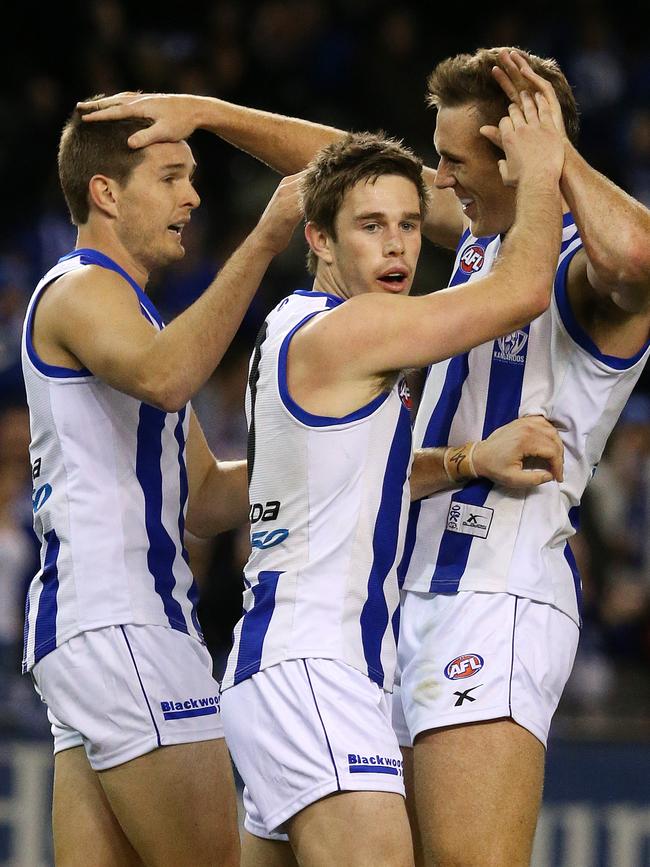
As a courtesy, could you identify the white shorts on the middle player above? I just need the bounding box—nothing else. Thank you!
[221,659,404,840]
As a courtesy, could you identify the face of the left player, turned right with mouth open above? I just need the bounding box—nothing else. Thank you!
[116,141,201,271]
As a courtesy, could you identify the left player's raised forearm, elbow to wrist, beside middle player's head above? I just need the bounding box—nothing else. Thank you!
[141,232,274,412]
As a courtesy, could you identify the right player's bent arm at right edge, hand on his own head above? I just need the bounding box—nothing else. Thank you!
[495,51,650,328]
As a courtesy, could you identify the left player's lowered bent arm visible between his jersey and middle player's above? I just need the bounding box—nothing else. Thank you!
[185,413,248,538]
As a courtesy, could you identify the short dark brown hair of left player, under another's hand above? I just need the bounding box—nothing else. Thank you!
[58,96,153,226]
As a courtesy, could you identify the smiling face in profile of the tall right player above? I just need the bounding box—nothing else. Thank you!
[433,105,515,237]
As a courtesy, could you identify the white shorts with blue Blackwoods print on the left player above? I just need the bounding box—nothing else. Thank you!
[32,625,223,771]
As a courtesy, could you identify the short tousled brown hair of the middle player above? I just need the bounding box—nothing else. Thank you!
[301,132,429,274]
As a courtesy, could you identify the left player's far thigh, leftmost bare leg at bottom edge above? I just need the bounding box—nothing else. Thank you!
[52,746,143,867]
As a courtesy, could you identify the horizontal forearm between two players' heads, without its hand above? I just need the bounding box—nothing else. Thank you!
[195,97,345,174]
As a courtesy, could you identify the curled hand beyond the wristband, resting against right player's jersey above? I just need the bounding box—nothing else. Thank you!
[473,415,564,488]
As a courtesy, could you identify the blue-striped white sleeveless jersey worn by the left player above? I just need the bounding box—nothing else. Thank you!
[22,249,200,671]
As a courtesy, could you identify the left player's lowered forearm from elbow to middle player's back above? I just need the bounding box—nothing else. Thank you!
[186,460,249,539]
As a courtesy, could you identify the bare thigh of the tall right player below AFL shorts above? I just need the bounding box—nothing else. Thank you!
[414,719,544,867]
